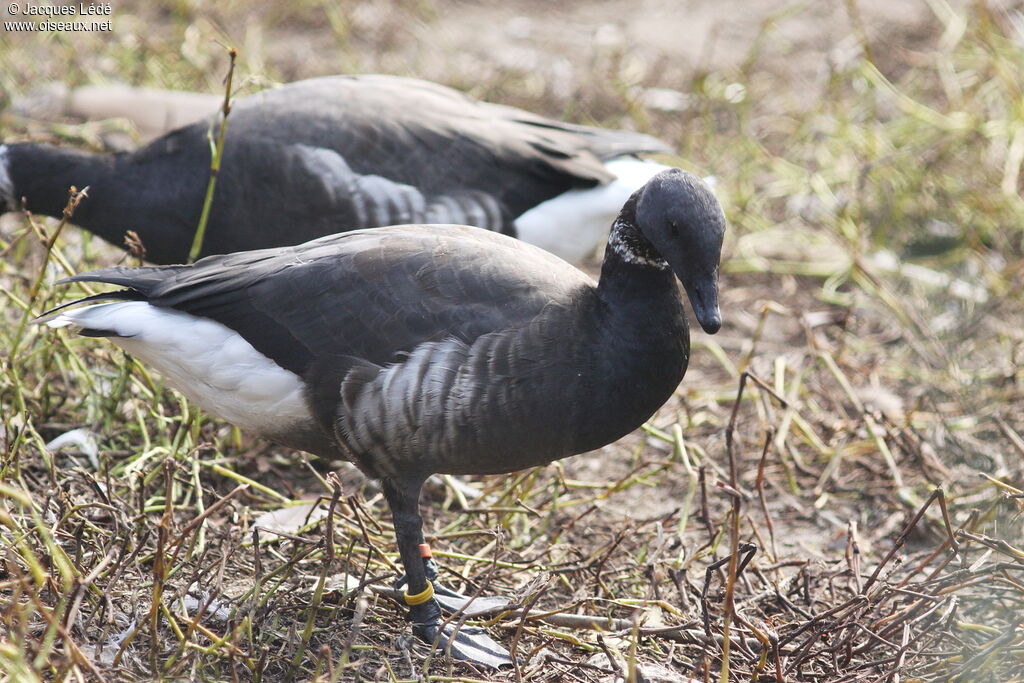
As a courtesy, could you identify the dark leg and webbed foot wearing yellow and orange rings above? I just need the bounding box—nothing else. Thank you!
[383,478,512,669]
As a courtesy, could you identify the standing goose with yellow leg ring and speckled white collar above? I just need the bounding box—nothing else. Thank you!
[41,169,725,664]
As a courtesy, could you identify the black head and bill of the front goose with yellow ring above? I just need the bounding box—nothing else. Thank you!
[636,168,725,334]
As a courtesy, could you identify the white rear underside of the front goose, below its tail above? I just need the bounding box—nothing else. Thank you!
[46,301,313,435]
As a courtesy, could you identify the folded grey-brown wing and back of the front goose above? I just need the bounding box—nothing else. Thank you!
[59,225,592,376]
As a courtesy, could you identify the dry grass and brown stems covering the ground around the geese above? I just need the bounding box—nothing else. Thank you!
[0,3,1024,683]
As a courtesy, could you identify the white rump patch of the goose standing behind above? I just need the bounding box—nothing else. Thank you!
[515,157,672,263]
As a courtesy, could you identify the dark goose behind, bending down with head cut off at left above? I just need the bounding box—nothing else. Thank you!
[0,76,671,263]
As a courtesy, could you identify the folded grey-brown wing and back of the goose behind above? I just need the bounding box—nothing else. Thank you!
[226,76,671,218]
